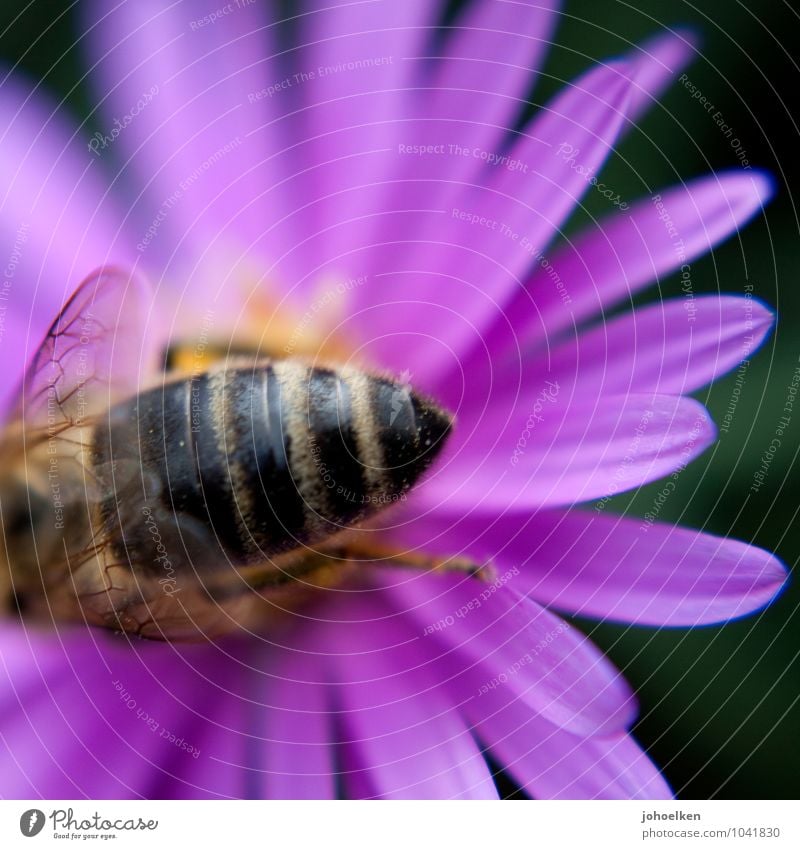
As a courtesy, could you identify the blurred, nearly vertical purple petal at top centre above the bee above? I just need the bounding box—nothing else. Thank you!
[280,0,440,300]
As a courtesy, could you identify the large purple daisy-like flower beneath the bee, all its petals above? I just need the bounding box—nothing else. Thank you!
[0,0,785,798]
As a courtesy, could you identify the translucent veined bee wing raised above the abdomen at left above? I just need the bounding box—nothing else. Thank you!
[12,267,151,435]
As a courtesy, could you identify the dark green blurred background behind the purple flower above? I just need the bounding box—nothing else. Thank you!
[0,0,800,799]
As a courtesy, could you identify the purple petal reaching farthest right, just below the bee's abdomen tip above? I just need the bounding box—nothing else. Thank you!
[384,506,786,626]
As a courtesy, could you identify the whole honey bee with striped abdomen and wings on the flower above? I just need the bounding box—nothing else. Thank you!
[0,268,474,640]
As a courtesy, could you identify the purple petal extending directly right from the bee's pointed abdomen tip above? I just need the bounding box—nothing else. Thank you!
[416,392,716,516]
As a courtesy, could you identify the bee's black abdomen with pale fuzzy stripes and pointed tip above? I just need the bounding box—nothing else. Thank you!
[94,359,450,575]
